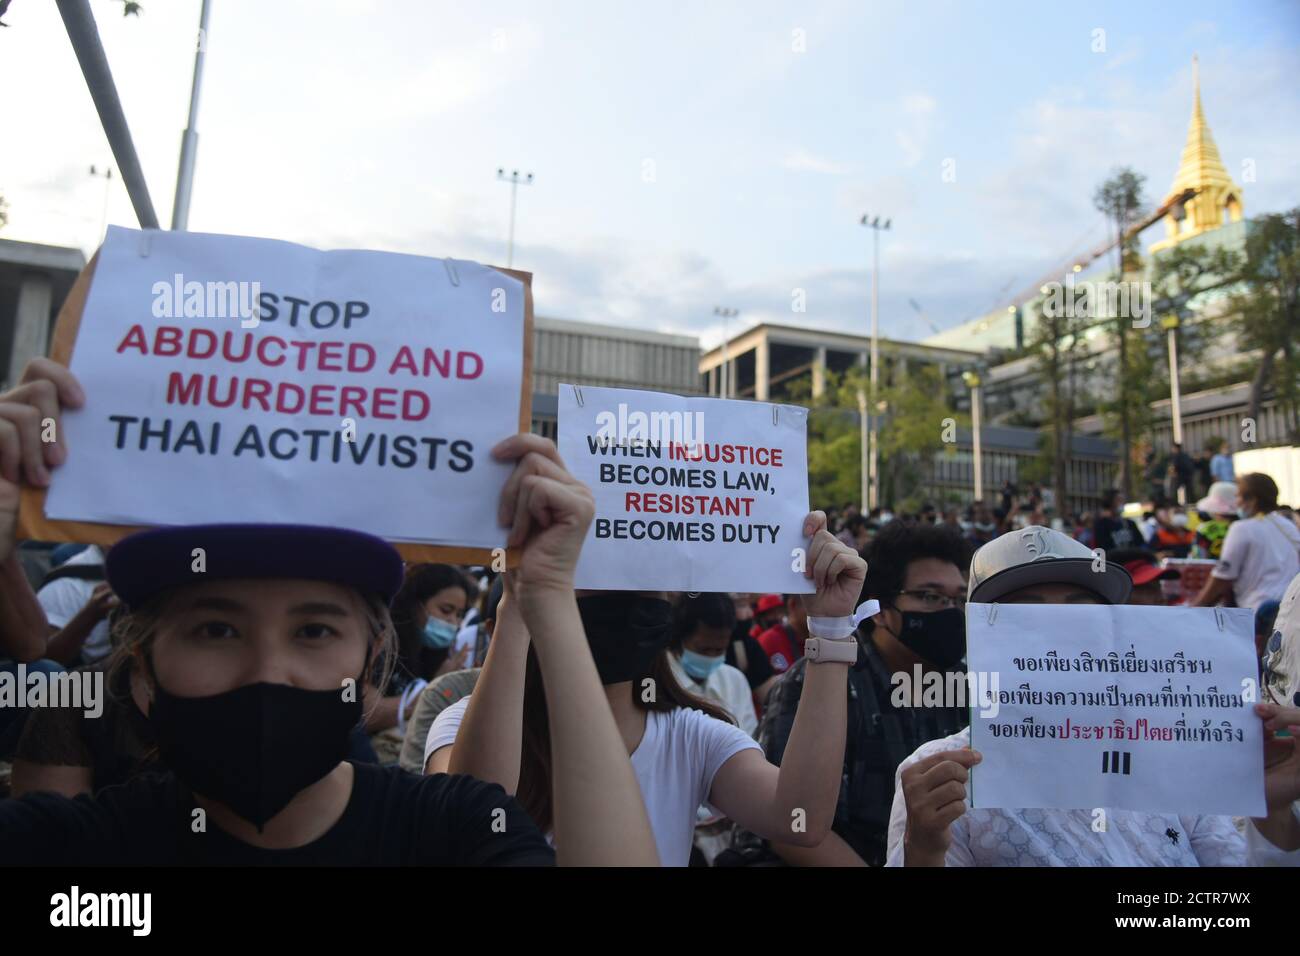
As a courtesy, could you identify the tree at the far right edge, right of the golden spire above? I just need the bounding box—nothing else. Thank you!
[1235,207,1300,444]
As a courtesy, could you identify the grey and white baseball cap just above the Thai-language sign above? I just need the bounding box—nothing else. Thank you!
[966,524,1134,604]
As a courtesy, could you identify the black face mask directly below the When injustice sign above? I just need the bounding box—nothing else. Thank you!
[577,592,672,684]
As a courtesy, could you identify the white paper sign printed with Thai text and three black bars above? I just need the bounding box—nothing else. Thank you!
[966,604,1265,817]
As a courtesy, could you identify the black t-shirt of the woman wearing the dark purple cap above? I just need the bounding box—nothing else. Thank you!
[0,763,555,866]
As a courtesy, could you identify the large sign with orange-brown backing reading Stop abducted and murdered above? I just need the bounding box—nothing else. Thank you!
[21,226,532,563]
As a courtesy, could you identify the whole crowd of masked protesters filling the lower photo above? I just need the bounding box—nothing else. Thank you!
[0,360,1300,866]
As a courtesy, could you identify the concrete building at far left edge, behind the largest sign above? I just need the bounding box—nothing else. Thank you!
[0,239,86,389]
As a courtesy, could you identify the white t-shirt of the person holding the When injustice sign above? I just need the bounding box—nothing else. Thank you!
[424,697,762,866]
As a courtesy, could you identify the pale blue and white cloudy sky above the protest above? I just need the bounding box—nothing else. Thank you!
[0,0,1300,343]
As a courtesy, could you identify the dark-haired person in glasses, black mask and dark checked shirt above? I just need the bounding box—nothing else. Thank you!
[735,522,970,866]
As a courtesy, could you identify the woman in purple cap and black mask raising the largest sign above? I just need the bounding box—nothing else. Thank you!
[0,363,657,865]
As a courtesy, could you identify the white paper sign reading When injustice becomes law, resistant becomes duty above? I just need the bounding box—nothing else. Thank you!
[559,385,815,593]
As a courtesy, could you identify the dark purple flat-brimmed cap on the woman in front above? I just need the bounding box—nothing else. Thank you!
[104,524,403,607]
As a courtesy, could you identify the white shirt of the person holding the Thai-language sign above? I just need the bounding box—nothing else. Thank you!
[885,727,1247,866]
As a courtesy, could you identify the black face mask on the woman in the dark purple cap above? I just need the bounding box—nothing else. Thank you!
[150,669,361,831]
